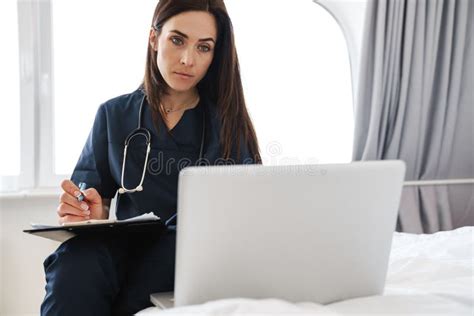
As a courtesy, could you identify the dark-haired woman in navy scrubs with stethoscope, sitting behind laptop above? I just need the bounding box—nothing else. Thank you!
[41,0,261,315]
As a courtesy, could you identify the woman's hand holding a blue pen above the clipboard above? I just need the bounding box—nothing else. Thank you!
[58,180,109,224]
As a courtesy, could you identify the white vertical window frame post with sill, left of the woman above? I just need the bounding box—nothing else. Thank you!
[14,0,68,191]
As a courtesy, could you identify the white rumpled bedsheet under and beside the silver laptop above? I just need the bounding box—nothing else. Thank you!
[138,227,474,316]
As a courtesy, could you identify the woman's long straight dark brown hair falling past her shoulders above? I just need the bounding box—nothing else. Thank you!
[143,0,262,163]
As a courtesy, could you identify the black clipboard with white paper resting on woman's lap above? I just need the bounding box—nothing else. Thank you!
[23,217,166,242]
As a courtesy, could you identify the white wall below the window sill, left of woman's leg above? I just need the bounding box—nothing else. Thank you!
[0,196,59,315]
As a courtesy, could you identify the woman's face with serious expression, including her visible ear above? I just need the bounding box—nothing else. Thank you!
[150,11,217,92]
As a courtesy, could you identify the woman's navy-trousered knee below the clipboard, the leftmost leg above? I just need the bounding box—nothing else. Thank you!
[41,236,127,315]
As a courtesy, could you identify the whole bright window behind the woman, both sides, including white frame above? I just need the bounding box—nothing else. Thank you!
[0,0,353,191]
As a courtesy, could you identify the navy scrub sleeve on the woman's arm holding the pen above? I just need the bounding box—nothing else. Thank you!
[71,105,118,199]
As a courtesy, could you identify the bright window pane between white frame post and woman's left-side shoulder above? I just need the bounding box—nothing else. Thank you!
[52,0,156,175]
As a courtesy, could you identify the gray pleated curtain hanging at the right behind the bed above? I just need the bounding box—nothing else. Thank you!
[353,0,474,233]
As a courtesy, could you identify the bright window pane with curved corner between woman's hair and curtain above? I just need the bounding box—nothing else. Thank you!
[226,0,353,164]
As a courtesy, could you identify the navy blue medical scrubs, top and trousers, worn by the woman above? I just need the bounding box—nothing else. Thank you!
[41,89,254,315]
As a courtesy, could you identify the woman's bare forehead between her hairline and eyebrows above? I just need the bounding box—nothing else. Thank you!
[163,11,217,39]
